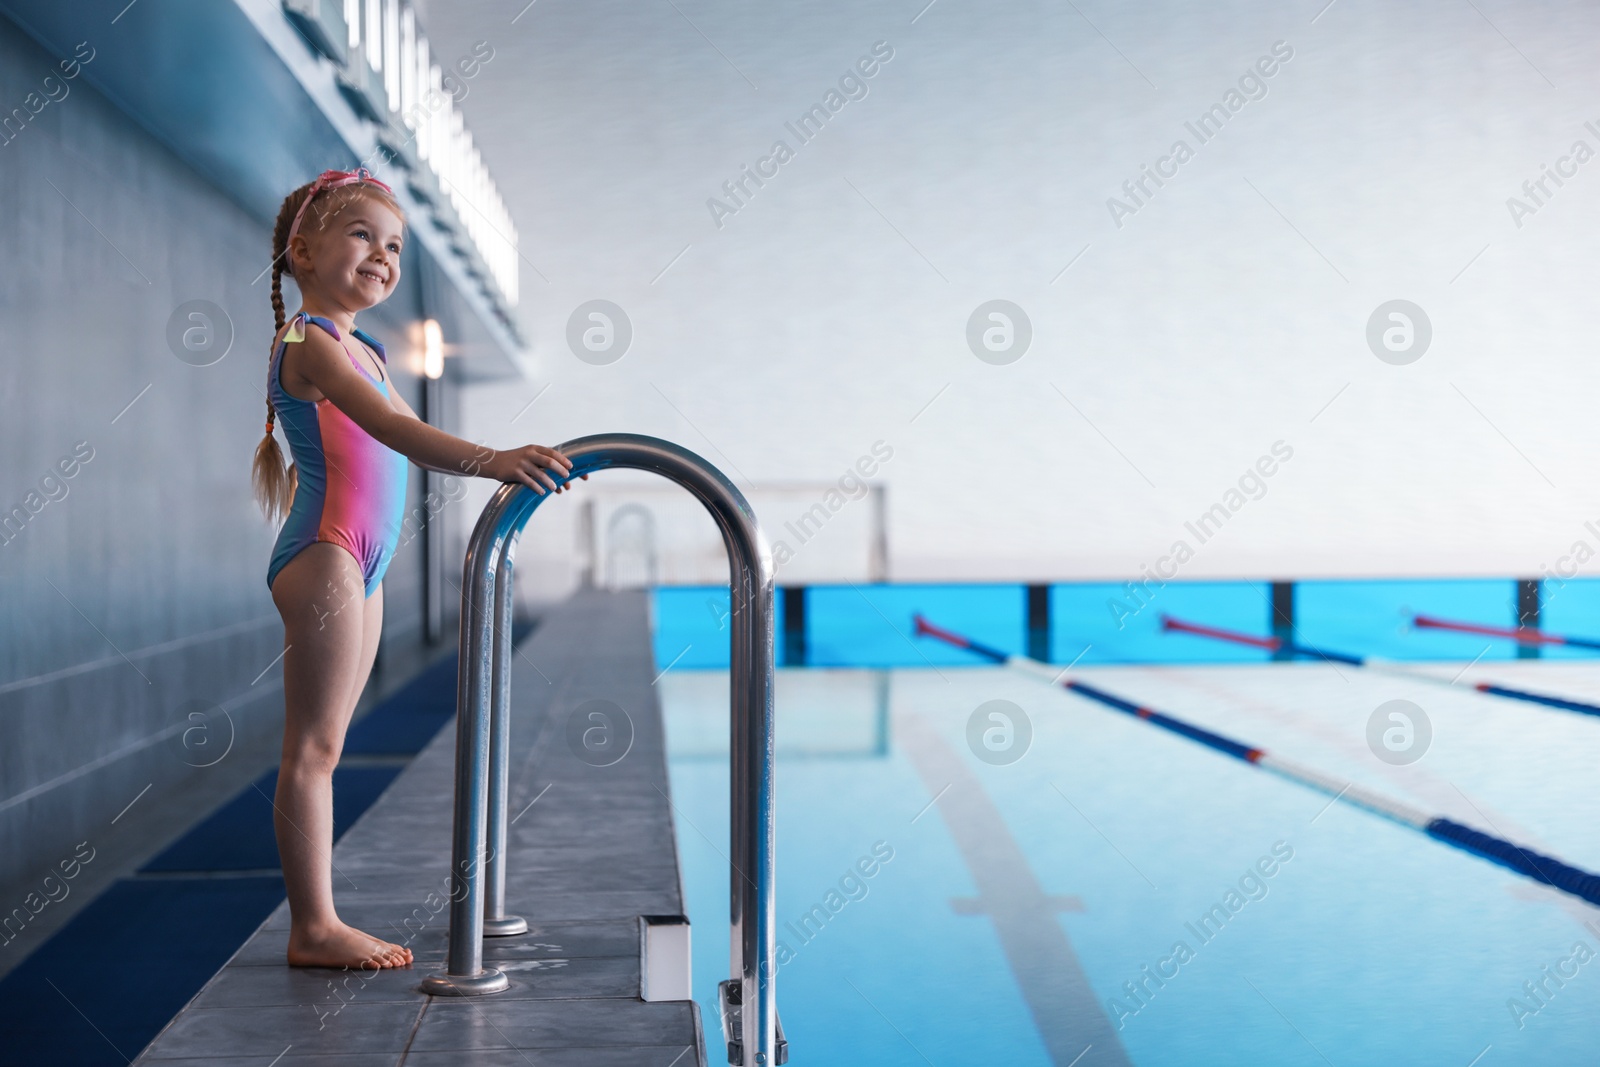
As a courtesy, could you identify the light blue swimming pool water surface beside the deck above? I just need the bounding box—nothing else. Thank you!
[658,590,1600,1067]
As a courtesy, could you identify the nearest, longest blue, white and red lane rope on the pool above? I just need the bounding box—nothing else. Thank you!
[914,614,1600,905]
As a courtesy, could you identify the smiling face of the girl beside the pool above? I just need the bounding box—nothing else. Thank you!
[290,197,405,312]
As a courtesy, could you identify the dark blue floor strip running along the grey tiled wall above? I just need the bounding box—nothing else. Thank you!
[0,621,550,1067]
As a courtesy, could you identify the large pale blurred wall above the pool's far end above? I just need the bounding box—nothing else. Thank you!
[406,0,1600,601]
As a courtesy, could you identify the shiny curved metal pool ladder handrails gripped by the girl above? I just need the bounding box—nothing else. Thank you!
[422,434,789,1067]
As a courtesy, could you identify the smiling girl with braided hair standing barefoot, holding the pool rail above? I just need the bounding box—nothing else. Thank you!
[253,168,571,968]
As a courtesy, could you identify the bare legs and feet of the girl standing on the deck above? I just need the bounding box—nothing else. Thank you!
[272,542,411,966]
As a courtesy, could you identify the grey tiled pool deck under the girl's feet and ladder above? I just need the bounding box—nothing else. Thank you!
[134,593,710,1067]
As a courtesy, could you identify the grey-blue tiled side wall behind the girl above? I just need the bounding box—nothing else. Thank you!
[0,18,462,912]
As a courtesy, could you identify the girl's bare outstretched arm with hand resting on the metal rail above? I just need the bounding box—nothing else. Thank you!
[285,330,573,494]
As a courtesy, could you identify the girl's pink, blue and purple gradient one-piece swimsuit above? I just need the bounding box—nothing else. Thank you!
[267,312,410,597]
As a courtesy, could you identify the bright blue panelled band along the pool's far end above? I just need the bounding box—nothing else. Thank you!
[654,579,1600,669]
